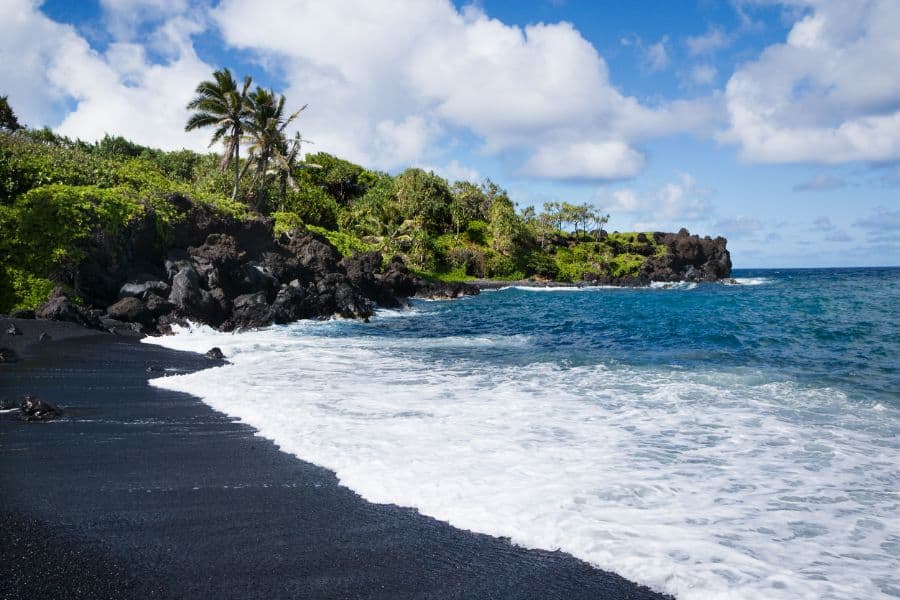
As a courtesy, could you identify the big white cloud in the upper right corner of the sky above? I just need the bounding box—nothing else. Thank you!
[721,0,900,164]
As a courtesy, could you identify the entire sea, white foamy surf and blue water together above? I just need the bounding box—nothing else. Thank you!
[147,268,900,599]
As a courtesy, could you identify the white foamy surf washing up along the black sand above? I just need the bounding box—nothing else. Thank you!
[148,323,900,599]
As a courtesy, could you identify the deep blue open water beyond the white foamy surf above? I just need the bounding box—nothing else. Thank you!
[332,267,900,406]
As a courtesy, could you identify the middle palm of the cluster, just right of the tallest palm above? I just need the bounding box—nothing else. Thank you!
[244,87,306,208]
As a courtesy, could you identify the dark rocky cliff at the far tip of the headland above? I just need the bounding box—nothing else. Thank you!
[640,229,731,281]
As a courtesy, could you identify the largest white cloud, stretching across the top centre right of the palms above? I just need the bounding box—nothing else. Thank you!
[213,0,720,178]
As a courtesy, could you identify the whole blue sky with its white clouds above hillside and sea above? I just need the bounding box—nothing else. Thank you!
[0,0,900,267]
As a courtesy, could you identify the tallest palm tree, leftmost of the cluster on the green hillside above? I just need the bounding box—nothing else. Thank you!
[184,68,251,200]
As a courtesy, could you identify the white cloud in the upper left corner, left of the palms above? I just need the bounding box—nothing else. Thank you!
[0,0,212,150]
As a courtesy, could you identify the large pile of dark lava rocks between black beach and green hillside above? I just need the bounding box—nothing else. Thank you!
[29,196,477,333]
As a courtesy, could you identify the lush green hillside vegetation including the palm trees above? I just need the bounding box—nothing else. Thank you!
[0,79,666,312]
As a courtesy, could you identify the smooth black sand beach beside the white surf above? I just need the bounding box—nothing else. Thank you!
[0,319,662,599]
